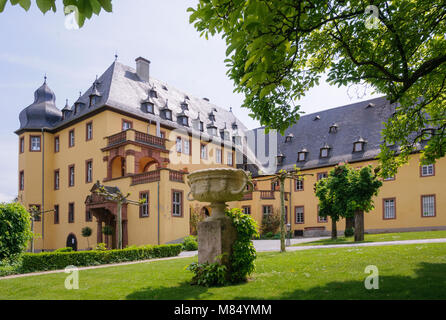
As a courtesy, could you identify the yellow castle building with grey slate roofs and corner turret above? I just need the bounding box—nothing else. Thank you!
[16,57,446,251]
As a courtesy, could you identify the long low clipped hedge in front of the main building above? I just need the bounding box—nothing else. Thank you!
[20,244,182,273]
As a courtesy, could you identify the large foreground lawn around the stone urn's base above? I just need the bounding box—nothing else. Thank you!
[0,243,446,299]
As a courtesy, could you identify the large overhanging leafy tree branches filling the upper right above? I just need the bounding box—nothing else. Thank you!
[188,0,446,176]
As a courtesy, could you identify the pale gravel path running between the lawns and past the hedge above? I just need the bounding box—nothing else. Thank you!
[0,237,446,280]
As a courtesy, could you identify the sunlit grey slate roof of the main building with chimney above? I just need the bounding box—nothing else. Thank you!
[46,61,246,140]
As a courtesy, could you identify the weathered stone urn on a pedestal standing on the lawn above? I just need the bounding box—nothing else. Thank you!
[187,168,253,266]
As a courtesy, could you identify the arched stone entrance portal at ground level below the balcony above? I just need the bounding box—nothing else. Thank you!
[85,181,128,249]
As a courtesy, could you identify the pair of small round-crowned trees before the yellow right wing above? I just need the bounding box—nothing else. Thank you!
[314,164,382,241]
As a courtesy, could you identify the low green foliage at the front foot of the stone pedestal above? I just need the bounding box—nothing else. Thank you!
[186,262,227,287]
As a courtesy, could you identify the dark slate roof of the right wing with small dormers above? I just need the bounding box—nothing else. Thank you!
[254,97,395,170]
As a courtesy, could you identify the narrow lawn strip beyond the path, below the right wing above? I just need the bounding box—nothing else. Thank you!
[294,230,446,246]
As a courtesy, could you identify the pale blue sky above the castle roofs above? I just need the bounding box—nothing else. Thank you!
[0,0,380,201]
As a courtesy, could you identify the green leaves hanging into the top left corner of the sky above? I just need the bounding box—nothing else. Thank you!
[0,0,113,27]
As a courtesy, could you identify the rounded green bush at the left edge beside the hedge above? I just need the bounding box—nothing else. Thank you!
[0,202,32,261]
